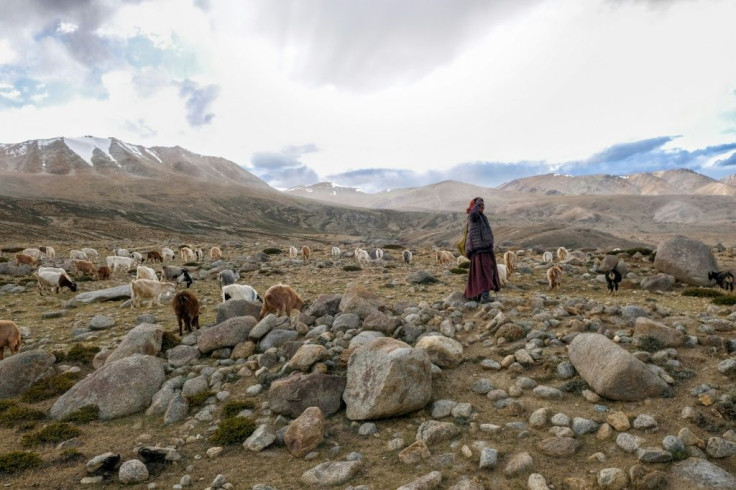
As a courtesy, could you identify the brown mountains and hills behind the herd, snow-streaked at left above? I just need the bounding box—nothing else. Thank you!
[0,136,736,247]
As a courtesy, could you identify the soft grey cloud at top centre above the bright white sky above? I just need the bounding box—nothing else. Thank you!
[254,0,540,91]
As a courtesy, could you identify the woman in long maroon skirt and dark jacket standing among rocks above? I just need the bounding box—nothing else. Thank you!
[465,197,501,303]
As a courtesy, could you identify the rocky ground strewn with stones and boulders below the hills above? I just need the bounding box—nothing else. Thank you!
[0,238,736,489]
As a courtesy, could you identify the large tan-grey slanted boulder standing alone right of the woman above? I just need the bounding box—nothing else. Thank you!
[568,333,672,401]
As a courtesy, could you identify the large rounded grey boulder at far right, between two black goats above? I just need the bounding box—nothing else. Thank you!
[654,236,718,286]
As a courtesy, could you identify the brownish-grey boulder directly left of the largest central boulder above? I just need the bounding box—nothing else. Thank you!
[268,373,347,419]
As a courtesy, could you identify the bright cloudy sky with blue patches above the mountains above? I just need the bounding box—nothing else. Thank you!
[0,0,736,192]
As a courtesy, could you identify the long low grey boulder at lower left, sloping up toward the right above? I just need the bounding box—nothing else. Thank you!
[49,354,166,420]
